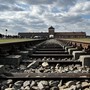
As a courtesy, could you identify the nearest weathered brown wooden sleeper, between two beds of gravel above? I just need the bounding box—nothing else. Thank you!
[7,73,90,79]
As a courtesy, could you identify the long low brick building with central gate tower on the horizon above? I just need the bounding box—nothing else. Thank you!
[18,26,86,38]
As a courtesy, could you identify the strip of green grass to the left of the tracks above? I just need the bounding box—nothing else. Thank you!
[0,39,35,44]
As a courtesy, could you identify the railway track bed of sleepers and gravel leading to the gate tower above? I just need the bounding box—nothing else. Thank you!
[0,39,90,90]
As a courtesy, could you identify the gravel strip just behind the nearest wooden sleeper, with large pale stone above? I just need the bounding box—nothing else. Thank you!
[5,61,90,73]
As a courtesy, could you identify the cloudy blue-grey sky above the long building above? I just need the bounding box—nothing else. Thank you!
[0,0,90,35]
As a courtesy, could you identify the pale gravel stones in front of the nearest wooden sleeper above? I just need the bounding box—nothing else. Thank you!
[0,79,90,90]
